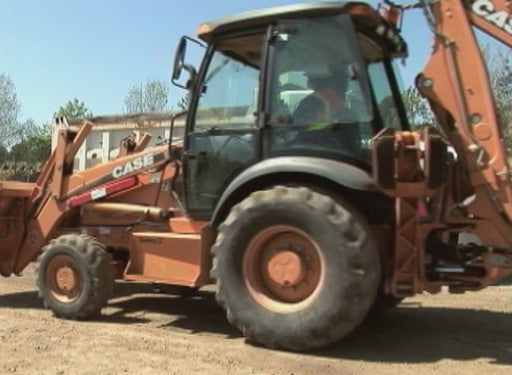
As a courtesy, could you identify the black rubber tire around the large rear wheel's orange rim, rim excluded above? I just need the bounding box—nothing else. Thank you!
[213,189,380,349]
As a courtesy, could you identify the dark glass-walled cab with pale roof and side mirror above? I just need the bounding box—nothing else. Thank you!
[173,2,407,218]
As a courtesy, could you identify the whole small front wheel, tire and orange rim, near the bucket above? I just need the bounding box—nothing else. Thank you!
[37,234,114,319]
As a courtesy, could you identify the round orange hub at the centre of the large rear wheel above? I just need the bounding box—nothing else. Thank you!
[267,250,306,287]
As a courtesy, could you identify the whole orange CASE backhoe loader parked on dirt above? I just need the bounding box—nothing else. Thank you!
[0,0,512,350]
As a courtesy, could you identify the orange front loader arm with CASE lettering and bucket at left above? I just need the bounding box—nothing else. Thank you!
[0,120,172,276]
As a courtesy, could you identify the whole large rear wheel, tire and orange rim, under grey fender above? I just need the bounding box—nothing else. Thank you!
[211,187,380,350]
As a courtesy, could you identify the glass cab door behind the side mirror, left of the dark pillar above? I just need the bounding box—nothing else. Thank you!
[183,45,261,219]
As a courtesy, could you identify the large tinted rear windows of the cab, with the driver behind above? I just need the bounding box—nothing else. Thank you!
[267,16,408,163]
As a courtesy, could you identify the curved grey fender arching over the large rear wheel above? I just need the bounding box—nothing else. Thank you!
[211,156,383,225]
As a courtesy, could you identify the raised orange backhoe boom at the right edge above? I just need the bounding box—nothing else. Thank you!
[416,0,512,247]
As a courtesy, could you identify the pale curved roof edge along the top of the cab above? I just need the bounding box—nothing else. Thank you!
[198,1,376,42]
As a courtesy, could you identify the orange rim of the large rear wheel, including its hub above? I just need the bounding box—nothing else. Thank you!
[242,225,324,313]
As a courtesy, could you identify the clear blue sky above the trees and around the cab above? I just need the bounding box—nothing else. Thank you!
[0,0,431,124]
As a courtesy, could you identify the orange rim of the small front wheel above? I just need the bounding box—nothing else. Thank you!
[46,255,83,303]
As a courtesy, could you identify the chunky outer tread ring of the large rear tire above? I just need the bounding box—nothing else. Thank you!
[211,186,380,351]
